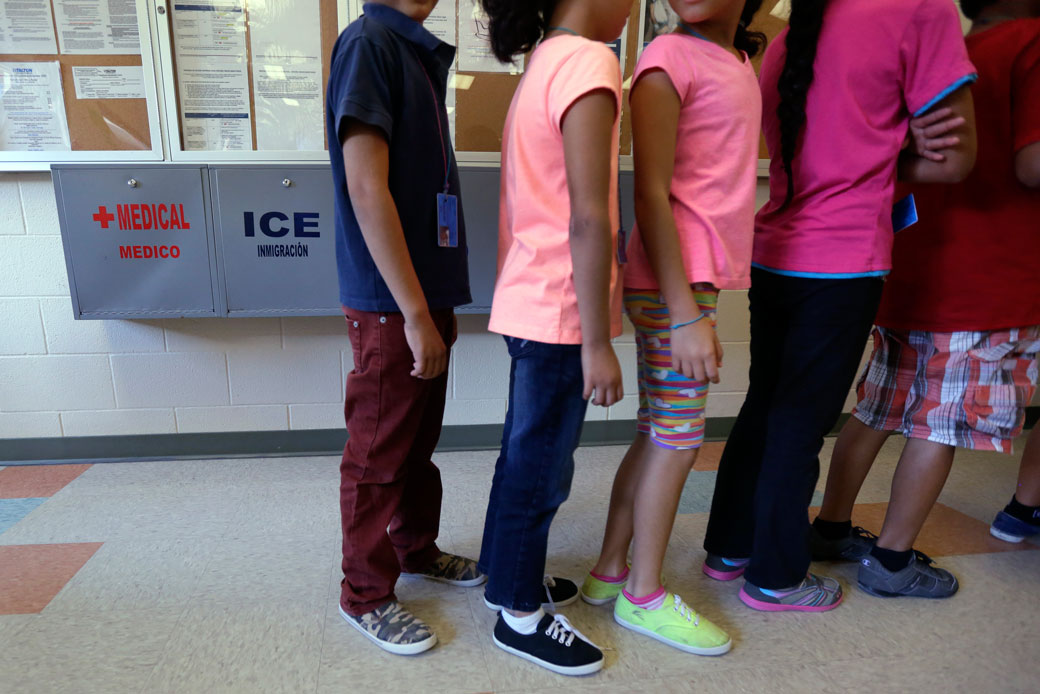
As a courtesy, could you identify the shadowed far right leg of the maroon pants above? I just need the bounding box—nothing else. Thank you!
[390,309,454,573]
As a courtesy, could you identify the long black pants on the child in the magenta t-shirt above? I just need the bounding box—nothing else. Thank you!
[704,269,884,589]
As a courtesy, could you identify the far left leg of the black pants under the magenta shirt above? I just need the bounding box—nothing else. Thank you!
[704,269,791,559]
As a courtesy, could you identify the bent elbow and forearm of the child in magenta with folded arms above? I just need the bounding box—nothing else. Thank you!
[900,87,978,183]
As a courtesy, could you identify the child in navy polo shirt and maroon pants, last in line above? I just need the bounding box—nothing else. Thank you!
[326,0,485,654]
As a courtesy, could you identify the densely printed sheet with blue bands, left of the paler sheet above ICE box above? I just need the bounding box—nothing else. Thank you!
[173,0,253,151]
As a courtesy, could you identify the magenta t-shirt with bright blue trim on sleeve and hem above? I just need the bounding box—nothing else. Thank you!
[754,0,976,277]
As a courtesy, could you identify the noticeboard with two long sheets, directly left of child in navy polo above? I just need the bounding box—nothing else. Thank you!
[158,0,345,162]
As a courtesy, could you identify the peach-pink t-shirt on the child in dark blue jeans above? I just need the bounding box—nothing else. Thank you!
[490,36,621,344]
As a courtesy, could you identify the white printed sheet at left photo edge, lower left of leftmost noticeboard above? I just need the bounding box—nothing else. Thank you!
[0,62,72,152]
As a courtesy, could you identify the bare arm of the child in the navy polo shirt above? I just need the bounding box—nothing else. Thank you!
[343,121,448,379]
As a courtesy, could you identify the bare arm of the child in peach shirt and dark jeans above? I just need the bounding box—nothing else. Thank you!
[562,89,624,407]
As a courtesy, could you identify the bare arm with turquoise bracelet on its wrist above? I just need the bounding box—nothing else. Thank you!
[630,70,722,383]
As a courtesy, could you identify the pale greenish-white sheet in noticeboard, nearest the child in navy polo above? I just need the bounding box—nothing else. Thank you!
[250,0,324,152]
